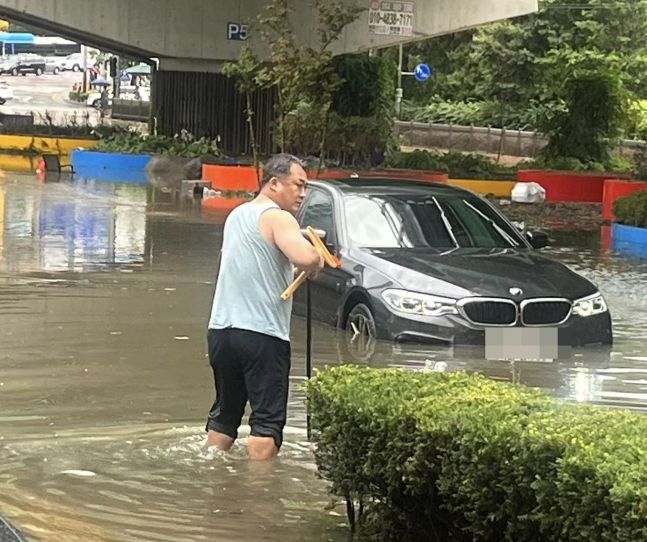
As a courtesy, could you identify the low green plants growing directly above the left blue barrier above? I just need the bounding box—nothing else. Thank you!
[93,131,221,158]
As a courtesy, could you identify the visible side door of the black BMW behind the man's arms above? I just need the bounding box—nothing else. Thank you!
[294,188,348,326]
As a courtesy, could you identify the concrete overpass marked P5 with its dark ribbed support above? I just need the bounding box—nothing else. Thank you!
[0,0,537,152]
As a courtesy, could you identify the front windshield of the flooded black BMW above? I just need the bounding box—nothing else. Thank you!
[344,194,526,249]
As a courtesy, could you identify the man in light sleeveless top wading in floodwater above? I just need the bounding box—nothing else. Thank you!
[206,154,324,459]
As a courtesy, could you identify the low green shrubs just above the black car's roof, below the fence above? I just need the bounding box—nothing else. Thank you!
[386,150,516,179]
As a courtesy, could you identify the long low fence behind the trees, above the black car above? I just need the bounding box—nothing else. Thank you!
[394,120,647,158]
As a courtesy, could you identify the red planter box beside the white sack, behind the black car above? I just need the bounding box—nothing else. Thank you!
[517,169,609,203]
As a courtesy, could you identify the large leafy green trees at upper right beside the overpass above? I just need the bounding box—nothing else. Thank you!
[404,0,647,148]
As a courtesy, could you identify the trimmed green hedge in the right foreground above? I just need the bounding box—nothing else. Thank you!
[307,366,647,542]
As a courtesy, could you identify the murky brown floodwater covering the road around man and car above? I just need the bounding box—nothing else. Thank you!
[0,174,647,542]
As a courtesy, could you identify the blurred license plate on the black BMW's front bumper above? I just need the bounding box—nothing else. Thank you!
[485,327,559,361]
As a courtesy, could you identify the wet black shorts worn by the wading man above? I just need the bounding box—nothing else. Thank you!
[206,328,290,448]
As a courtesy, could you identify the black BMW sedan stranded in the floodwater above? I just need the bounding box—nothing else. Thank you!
[294,178,612,359]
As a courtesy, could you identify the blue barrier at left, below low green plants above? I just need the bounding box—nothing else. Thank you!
[71,151,152,183]
